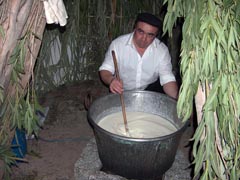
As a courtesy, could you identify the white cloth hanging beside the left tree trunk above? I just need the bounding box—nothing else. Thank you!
[43,0,68,26]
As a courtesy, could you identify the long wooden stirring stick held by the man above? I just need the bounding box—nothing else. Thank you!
[112,51,129,134]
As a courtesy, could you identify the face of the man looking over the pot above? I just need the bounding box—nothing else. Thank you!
[133,21,158,49]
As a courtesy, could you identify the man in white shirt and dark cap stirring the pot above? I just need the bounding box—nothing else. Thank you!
[99,13,178,99]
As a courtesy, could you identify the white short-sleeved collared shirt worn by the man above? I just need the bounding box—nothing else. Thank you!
[99,33,176,90]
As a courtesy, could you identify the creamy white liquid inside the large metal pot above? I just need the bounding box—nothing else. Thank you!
[98,112,177,138]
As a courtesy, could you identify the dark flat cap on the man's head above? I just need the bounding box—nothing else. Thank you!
[135,13,161,29]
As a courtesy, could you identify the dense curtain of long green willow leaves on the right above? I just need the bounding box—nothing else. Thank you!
[164,0,240,180]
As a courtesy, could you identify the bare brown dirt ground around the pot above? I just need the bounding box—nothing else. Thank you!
[11,81,195,180]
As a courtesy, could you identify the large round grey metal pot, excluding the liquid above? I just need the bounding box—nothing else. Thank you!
[88,91,187,180]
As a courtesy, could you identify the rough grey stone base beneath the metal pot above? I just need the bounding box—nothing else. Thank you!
[74,138,191,180]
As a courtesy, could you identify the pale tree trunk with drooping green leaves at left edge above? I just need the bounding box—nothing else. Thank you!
[0,0,46,179]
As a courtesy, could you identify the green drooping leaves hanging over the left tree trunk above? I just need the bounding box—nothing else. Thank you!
[0,33,42,179]
